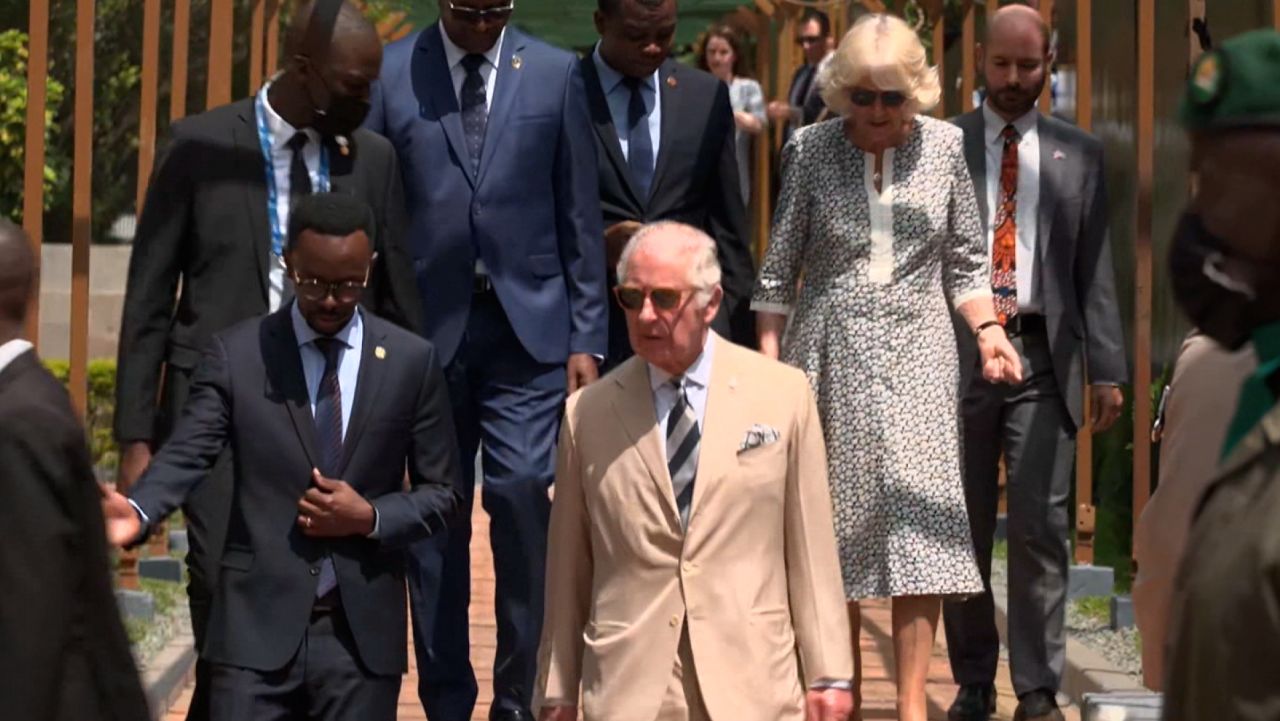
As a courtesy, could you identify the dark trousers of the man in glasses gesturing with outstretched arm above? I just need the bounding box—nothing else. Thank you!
[209,608,401,721]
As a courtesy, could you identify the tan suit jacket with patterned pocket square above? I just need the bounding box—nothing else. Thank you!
[535,337,854,721]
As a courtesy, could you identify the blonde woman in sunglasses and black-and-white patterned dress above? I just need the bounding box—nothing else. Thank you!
[751,15,1021,721]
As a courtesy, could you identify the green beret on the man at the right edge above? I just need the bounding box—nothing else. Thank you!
[1179,29,1280,131]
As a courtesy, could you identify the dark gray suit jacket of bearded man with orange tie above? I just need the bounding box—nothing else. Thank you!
[955,108,1128,426]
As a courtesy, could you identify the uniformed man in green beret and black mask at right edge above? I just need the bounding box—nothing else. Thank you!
[1165,29,1280,721]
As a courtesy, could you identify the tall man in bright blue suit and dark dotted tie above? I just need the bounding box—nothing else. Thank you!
[366,0,608,721]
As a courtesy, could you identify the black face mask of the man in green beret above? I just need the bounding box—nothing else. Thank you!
[1169,211,1280,351]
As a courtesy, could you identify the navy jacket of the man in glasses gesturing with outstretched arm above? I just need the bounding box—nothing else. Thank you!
[129,309,461,675]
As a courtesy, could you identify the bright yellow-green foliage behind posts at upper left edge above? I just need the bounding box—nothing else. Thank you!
[0,29,69,223]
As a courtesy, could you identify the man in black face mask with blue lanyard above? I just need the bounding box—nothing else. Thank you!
[115,0,421,718]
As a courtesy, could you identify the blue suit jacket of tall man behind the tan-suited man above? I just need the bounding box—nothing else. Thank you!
[365,24,608,365]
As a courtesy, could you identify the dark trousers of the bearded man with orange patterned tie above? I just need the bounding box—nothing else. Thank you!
[943,333,1075,694]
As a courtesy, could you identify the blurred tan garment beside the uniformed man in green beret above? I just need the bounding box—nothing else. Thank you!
[1133,334,1258,690]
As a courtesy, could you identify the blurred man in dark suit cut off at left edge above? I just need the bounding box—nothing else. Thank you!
[0,219,150,721]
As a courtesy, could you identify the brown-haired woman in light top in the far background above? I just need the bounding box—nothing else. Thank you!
[698,26,768,204]
